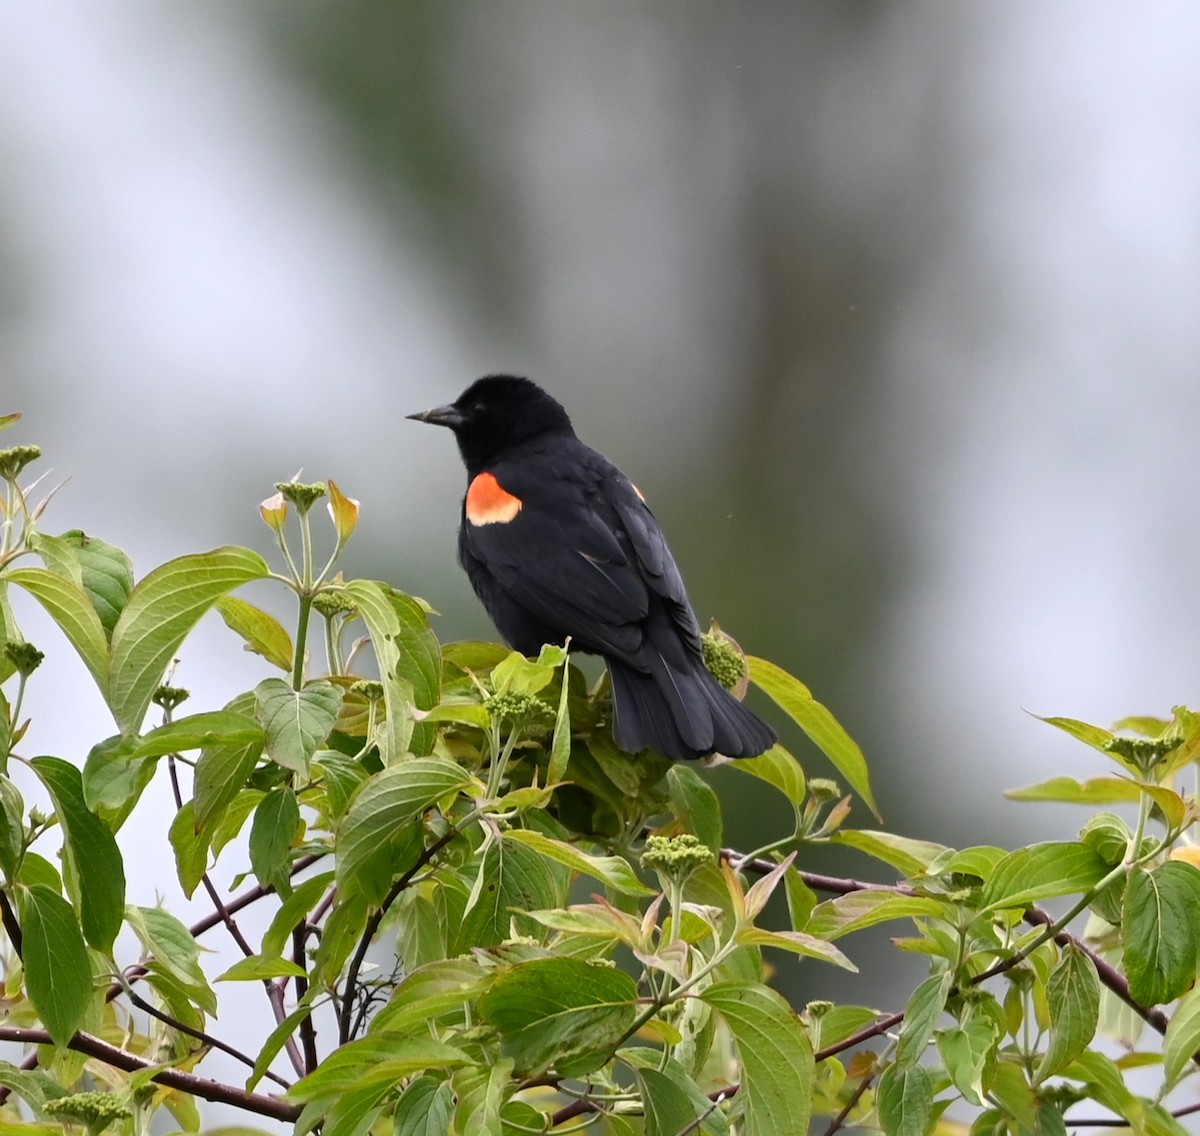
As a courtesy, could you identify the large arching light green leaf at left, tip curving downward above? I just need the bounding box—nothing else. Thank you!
[106,547,270,733]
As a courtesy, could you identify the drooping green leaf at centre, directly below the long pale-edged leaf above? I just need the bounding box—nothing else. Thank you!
[455,834,566,951]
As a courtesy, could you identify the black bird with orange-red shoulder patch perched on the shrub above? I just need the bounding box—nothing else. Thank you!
[409,374,775,761]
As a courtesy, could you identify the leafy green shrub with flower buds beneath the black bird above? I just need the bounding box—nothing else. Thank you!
[0,416,1200,1136]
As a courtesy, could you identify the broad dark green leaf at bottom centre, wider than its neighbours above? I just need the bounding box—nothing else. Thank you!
[479,958,637,1077]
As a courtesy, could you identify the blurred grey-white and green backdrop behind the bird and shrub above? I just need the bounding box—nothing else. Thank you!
[0,0,1200,1118]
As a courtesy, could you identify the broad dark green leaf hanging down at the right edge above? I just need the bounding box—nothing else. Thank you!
[1123,860,1198,1006]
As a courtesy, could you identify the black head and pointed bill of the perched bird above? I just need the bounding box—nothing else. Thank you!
[408,374,574,476]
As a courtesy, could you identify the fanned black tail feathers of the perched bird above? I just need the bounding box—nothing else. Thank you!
[608,655,776,762]
